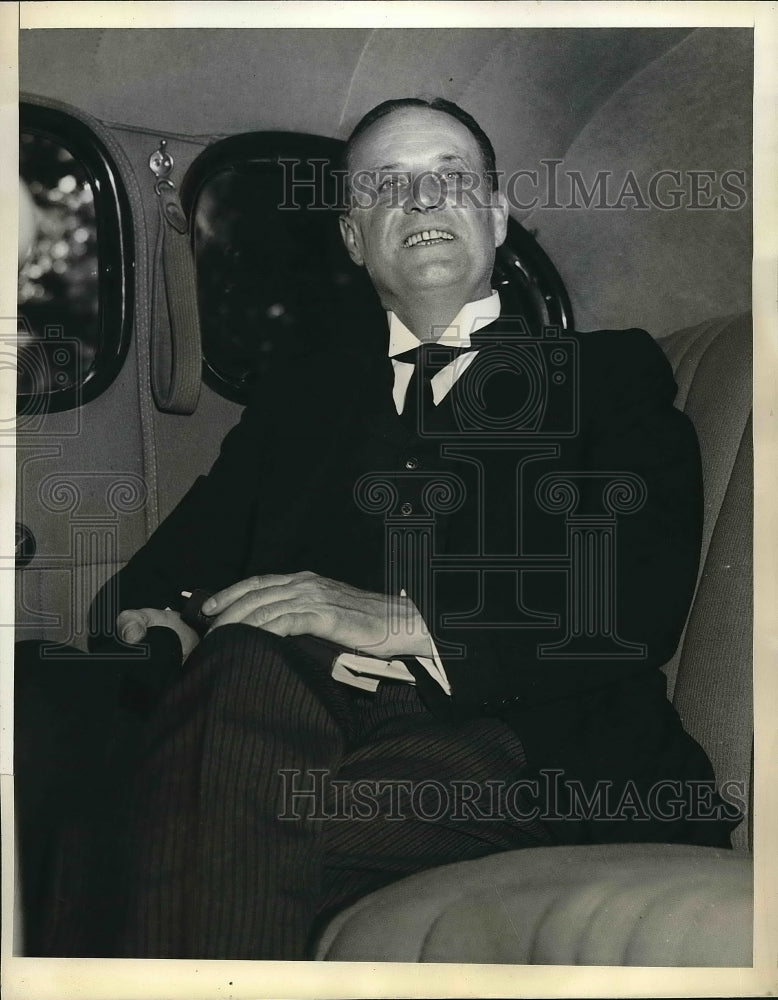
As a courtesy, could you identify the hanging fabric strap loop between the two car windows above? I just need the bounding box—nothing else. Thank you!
[151,146,202,414]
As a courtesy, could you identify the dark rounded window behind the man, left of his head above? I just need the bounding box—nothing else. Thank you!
[182,133,383,402]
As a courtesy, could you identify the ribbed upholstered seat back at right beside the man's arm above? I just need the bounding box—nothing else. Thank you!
[660,315,753,848]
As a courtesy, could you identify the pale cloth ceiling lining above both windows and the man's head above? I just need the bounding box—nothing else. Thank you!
[20,28,691,141]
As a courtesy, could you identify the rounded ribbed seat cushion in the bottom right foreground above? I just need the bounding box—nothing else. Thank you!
[316,844,753,966]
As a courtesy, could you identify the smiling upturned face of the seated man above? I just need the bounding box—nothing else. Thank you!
[341,107,507,309]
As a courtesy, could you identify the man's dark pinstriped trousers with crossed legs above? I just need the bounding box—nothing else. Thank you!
[21,625,550,959]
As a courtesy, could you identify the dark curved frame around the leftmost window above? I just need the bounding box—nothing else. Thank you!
[16,101,135,414]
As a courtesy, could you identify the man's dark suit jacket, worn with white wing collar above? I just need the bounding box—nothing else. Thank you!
[98,321,731,844]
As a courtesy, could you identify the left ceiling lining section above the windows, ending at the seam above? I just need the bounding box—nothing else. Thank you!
[19,28,372,135]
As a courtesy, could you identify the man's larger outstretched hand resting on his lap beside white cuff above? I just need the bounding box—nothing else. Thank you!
[203,572,433,657]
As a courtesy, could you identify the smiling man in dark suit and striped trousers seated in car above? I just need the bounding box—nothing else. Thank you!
[21,100,732,958]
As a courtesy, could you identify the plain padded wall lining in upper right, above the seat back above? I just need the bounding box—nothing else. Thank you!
[524,29,753,337]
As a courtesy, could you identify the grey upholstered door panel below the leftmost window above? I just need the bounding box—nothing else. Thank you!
[16,316,149,646]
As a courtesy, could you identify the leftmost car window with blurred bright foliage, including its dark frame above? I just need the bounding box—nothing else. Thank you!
[17,104,134,413]
